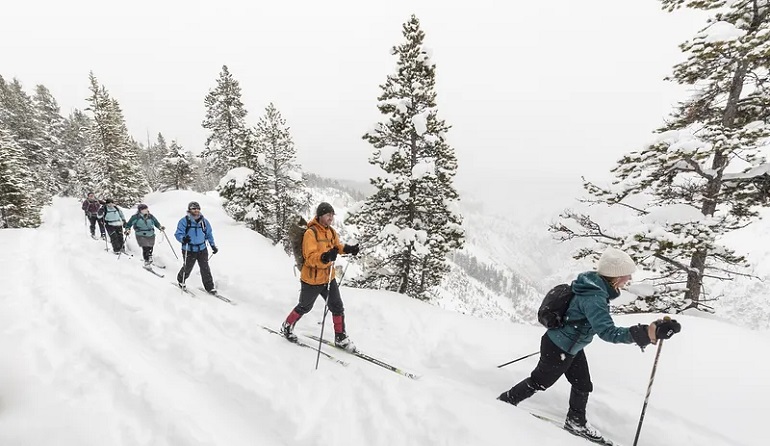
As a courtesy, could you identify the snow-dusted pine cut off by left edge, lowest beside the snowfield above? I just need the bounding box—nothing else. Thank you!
[0,125,41,228]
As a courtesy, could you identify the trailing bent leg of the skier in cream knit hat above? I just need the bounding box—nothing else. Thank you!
[497,334,574,406]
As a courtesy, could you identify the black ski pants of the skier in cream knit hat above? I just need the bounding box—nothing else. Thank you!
[501,333,594,424]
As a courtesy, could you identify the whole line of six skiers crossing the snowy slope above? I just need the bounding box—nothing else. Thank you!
[83,194,681,444]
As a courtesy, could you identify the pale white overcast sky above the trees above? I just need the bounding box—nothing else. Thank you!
[0,0,704,219]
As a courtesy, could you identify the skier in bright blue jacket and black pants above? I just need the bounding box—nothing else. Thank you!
[174,201,219,294]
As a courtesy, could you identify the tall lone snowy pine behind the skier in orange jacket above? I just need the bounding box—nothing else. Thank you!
[347,15,465,299]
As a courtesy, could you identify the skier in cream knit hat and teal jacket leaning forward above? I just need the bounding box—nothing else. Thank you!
[497,248,681,443]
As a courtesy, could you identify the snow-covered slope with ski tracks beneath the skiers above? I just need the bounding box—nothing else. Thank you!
[0,192,770,446]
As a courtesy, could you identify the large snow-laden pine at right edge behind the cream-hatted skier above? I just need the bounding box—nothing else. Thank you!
[551,0,770,312]
